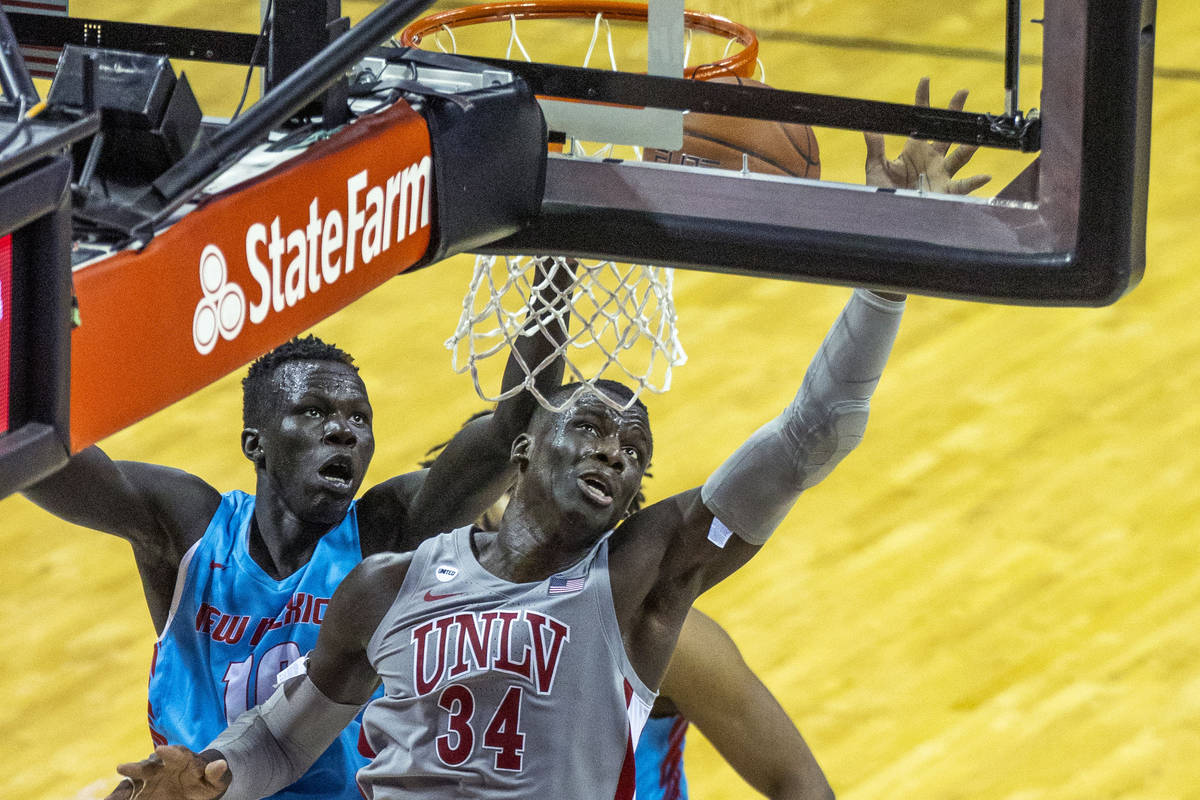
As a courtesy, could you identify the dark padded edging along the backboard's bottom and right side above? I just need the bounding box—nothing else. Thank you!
[485,0,1156,306]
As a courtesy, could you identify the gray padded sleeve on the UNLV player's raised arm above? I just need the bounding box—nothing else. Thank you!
[701,289,905,545]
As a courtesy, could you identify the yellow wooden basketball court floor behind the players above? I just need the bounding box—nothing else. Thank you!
[0,0,1200,800]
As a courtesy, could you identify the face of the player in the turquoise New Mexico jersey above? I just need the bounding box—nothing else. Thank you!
[242,361,374,525]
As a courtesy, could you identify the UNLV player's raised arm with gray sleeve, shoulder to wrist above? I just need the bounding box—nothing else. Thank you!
[612,289,905,685]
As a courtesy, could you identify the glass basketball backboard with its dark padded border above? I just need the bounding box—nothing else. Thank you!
[400,0,1154,305]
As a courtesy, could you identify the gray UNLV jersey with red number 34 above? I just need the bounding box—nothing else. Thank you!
[359,528,654,800]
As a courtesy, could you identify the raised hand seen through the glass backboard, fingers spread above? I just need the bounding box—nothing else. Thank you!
[863,78,991,194]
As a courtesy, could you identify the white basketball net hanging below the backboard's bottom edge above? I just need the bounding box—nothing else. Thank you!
[446,255,688,411]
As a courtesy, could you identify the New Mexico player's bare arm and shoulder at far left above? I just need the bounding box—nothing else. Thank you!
[23,447,221,631]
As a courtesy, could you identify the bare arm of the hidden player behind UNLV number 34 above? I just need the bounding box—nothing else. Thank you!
[662,609,834,800]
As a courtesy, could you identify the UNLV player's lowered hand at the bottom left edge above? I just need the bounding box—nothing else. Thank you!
[104,745,232,800]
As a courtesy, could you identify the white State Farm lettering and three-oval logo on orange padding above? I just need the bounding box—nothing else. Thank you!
[192,156,433,355]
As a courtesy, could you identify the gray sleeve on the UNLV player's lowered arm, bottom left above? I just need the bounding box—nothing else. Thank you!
[209,675,362,800]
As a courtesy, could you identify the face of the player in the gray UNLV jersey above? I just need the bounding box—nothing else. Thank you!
[513,392,653,534]
